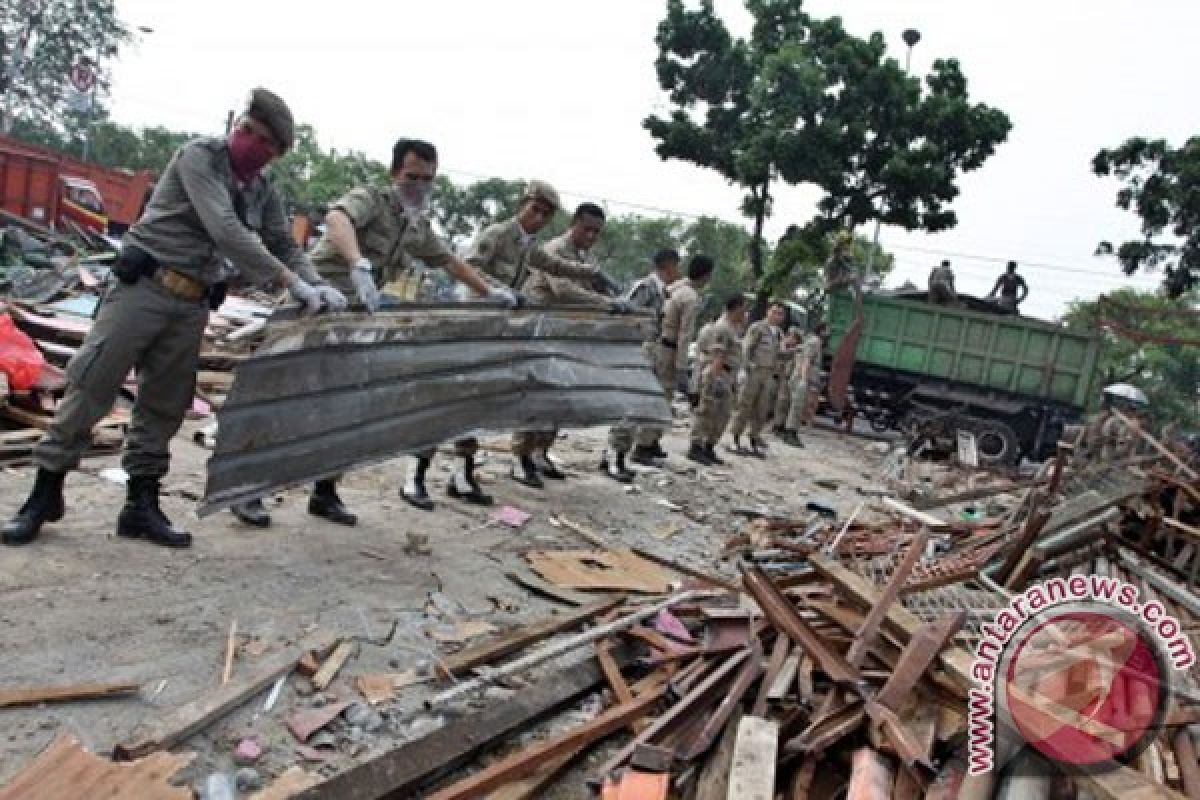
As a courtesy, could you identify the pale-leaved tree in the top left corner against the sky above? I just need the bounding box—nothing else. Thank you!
[0,0,132,133]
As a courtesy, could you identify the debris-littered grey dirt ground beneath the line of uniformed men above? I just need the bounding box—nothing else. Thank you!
[0,410,883,798]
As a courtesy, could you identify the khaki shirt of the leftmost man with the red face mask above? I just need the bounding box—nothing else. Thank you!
[125,137,322,284]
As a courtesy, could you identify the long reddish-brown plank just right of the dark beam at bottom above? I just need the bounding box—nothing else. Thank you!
[426,690,665,800]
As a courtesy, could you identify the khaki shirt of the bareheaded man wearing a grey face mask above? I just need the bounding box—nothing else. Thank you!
[312,186,454,291]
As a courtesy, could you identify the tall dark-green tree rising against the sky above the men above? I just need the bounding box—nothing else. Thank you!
[643,0,1010,290]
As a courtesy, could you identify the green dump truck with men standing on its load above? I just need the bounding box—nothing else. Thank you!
[826,291,1100,464]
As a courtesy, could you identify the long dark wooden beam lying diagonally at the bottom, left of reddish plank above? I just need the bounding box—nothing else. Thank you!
[296,654,629,800]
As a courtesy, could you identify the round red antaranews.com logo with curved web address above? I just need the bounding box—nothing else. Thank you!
[968,575,1195,775]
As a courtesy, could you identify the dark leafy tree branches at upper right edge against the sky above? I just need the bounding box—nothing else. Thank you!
[1092,137,1200,297]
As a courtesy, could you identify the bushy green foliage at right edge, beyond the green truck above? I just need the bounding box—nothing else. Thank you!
[1063,289,1200,427]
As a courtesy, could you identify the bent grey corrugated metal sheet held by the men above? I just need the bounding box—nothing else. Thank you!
[199,305,671,515]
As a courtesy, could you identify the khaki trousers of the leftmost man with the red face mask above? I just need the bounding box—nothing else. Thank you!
[34,278,209,477]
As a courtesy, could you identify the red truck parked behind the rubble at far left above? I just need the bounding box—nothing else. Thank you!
[0,136,154,235]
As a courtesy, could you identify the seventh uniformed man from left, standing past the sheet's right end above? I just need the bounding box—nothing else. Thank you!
[688,294,746,467]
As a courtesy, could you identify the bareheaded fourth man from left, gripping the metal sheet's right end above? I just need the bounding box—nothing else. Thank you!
[512,203,634,483]
